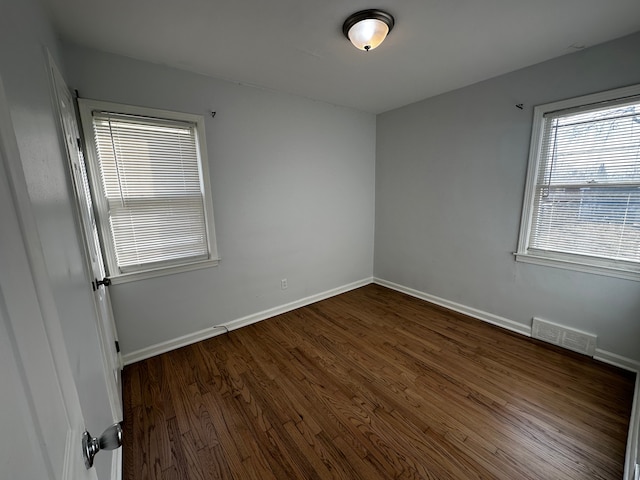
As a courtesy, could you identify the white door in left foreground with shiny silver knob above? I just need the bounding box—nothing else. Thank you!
[0,75,96,480]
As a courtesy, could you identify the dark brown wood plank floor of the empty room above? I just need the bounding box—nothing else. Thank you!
[124,285,635,480]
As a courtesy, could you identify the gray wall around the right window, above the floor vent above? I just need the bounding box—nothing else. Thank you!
[374,34,640,361]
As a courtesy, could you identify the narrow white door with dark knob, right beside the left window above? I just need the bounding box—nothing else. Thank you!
[49,57,122,421]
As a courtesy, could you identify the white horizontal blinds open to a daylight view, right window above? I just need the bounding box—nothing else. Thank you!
[529,98,640,263]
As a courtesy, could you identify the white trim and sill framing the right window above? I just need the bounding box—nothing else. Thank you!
[514,85,640,281]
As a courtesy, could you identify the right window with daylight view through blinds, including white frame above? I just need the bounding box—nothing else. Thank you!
[516,85,640,280]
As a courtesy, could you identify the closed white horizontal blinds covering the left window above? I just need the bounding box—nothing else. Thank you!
[93,112,209,273]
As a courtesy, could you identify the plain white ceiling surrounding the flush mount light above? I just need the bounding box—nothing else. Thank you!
[42,0,640,113]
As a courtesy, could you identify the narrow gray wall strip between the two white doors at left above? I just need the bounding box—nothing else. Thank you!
[0,0,113,478]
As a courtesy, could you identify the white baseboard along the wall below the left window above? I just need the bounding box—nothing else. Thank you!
[122,277,373,365]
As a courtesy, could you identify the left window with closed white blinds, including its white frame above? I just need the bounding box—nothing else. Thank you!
[79,99,218,283]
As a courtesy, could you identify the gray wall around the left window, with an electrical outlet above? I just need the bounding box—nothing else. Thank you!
[64,45,376,354]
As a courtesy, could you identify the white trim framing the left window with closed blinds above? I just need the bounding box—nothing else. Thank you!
[78,98,220,284]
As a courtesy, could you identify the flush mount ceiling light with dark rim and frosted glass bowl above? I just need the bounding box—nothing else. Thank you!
[342,10,395,52]
